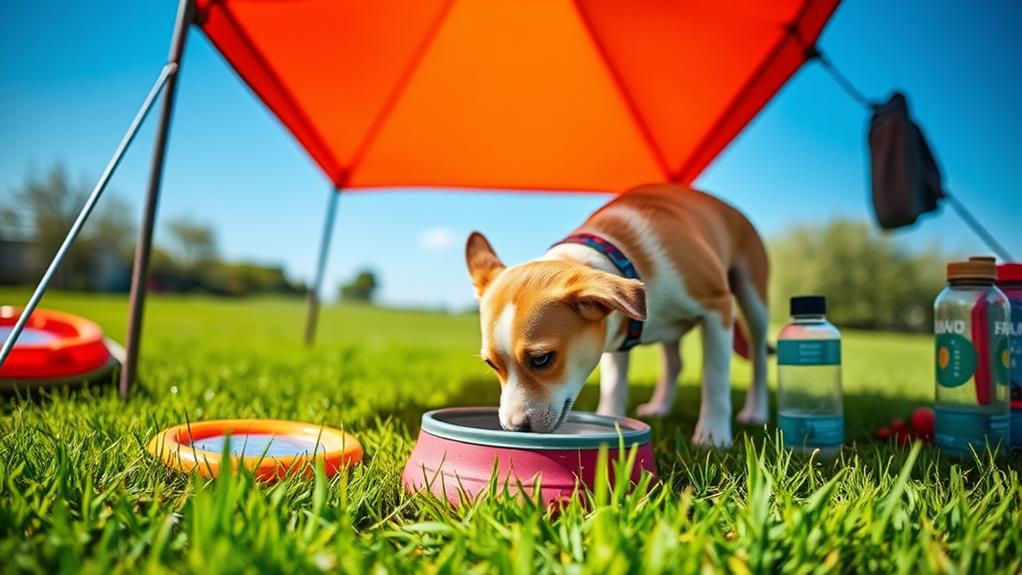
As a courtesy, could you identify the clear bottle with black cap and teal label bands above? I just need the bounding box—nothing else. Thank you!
[777,295,844,456]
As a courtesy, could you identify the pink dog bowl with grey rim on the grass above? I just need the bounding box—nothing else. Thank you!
[403,408,656,505]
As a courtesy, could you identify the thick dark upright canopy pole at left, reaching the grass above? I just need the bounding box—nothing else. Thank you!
[118,0,195,400]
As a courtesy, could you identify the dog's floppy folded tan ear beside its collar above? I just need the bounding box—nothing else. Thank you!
[567,271,646,322]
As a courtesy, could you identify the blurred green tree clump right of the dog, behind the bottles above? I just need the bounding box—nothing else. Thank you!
[769,220,946,331]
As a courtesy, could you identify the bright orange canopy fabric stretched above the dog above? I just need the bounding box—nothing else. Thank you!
[197,0,838,192]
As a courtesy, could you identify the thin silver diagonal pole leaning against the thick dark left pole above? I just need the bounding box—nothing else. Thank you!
[0,62,178,366]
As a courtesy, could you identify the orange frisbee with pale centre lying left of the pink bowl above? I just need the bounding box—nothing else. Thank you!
[147,419,362,481]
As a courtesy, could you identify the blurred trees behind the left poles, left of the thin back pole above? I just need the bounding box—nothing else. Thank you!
[0,165,306,296]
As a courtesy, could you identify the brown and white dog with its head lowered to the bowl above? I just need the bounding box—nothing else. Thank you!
[465,184,769,446]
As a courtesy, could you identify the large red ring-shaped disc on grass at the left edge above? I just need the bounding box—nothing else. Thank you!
[0,305,124,389]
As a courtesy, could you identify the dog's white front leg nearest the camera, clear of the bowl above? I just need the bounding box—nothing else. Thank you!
[692,312,734,447]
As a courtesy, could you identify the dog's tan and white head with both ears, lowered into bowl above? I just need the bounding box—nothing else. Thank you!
[465,232,646,432]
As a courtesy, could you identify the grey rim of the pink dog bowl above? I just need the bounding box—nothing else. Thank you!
[421,408,652,450]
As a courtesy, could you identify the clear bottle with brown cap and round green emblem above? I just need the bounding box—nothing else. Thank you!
[933,257,1011,456]
